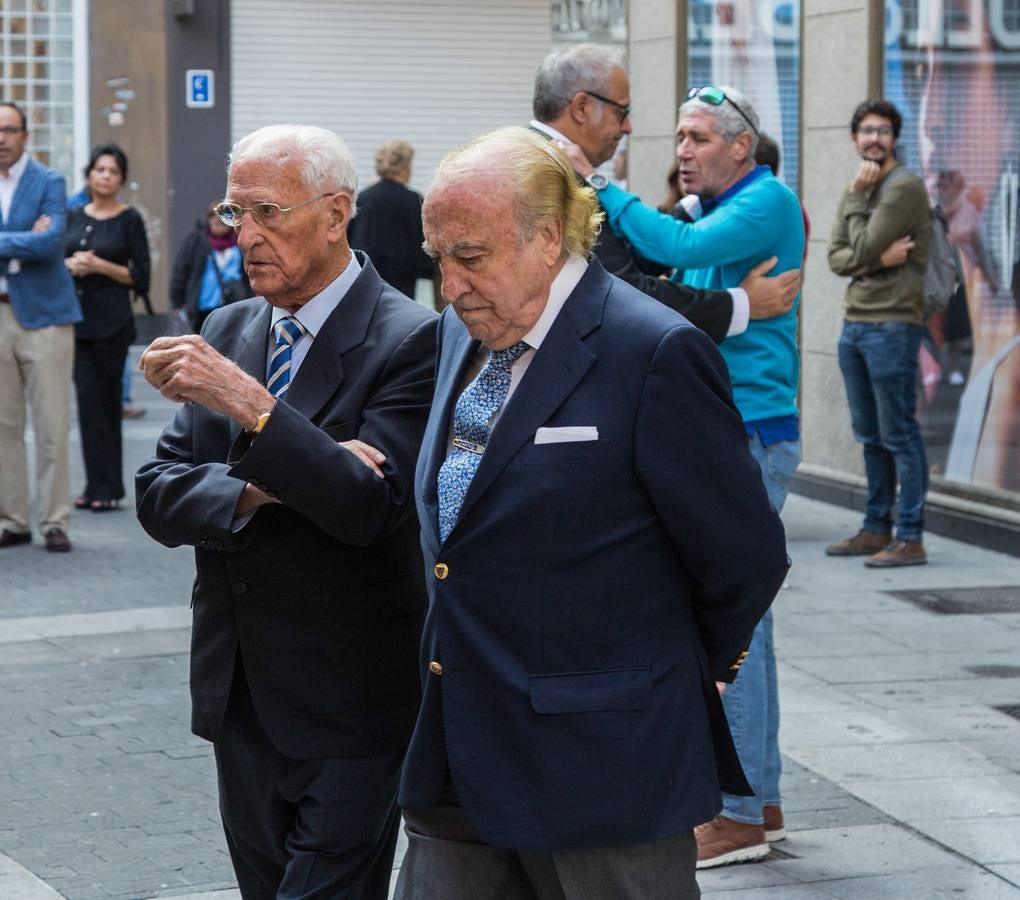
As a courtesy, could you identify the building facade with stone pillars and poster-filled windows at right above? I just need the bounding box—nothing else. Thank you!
[629,0,1020,538]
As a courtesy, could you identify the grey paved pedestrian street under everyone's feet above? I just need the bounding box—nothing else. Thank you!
[0,353,1020,900]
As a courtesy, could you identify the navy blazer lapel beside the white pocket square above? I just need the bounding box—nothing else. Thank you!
[454,255,612,532]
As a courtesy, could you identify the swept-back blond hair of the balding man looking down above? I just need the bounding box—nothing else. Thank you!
[429,126,605,256]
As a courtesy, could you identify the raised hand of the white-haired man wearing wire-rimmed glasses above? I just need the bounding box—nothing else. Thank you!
[138,335,275,429]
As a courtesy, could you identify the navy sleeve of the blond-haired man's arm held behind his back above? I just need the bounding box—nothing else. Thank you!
[634,326,788,682]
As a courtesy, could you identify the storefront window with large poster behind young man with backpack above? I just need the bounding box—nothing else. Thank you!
[884,0,1020,499]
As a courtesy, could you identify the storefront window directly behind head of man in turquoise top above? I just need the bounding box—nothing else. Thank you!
[687,0,801,190]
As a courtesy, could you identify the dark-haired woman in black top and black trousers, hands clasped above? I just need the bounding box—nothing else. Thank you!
[64,144,149,512]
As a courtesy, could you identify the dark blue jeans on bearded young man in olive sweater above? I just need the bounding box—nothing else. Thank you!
[839,321,928,541]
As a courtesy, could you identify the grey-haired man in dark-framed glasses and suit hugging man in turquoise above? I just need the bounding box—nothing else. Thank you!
[531,44,801,343]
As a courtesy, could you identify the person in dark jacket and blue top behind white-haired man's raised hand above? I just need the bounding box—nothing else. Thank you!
[170,200,252,334]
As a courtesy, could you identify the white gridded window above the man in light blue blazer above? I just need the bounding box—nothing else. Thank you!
[0,0,74,184]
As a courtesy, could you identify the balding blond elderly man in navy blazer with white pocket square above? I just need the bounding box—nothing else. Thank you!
[397,129,788,900]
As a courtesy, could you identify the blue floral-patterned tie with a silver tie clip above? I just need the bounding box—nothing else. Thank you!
[438,341,528,541]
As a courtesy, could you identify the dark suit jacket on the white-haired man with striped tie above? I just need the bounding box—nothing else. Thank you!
[136,255,437,759]
